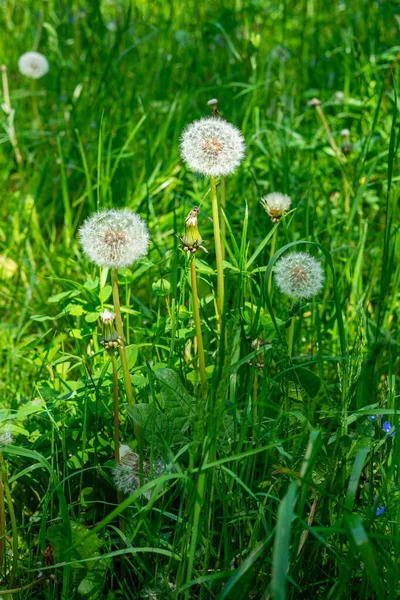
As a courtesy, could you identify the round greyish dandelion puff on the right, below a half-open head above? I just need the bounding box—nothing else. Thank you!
[275,252,324,298]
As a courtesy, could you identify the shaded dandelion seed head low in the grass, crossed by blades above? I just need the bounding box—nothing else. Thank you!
[113,444,165,500]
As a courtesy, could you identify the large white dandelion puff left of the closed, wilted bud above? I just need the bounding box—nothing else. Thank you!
[79,208,149,268]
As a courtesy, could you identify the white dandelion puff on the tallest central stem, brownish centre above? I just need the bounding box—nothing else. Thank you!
[181,116,245,176]
